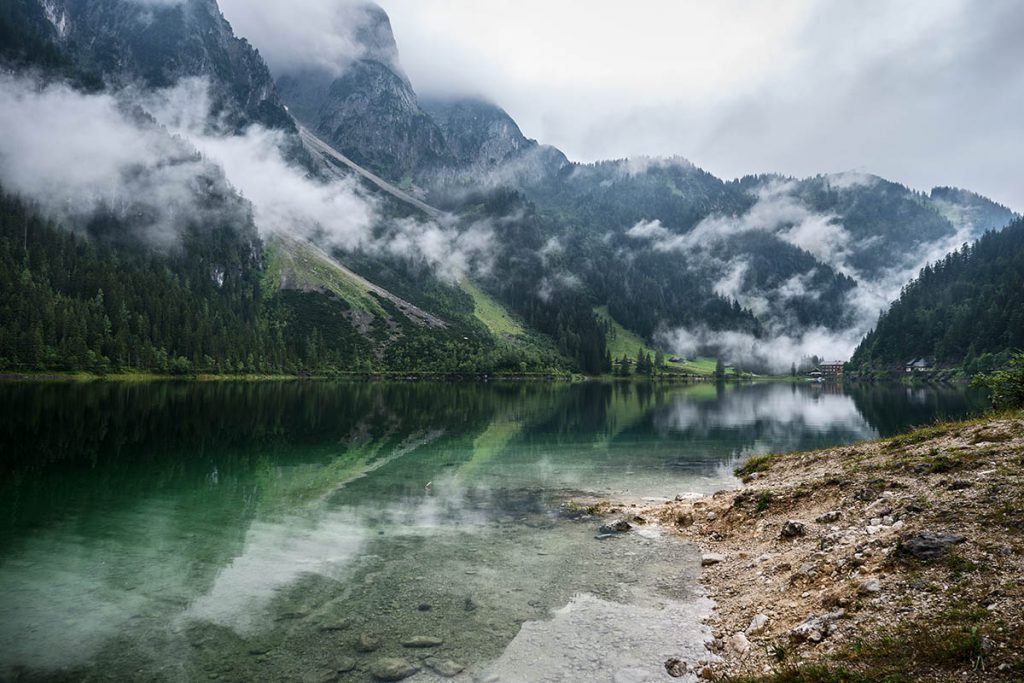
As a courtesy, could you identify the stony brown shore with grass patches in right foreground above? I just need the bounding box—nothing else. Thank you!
[614,412,1024,683]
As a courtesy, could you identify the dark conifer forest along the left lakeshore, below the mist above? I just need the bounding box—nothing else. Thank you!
[0,188,589,375]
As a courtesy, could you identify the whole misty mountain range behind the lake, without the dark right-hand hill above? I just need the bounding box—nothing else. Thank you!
[0,0,1015,373]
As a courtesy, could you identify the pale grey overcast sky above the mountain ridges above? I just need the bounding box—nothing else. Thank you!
[221,0,1024,211]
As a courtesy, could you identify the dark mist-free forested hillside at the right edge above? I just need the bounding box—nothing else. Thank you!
[850,219,1024,374]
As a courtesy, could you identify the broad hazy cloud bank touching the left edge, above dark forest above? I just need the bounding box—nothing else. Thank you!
[0,76,244,247]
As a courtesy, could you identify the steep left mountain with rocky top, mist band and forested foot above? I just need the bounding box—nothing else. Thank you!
[0,0,574,374]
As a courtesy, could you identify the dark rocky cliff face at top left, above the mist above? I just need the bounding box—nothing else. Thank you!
[42,0,294,130]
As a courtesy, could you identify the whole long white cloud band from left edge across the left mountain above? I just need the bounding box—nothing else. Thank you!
[0,77,493,281]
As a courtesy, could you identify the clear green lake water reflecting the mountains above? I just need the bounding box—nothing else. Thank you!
[0,382,985,681]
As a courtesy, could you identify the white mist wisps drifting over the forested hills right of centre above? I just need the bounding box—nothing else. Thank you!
[626,178,973,372]
